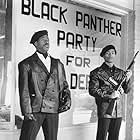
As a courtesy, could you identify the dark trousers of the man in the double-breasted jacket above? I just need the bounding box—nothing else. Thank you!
[20,112,58,140]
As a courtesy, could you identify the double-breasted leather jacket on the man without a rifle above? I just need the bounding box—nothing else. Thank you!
[18,53,70,115]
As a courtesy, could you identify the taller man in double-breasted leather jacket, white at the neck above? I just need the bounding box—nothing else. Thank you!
[18,30,70,140]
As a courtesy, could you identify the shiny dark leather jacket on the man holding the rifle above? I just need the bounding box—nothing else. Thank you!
[89,63,130,118]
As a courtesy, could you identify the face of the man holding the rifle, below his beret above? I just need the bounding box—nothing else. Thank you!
[103,49,116,63]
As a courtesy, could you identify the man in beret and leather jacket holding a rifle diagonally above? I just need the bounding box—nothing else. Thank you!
[89,45,132,140]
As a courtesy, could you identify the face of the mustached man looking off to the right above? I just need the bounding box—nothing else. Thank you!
[34,35,49,53]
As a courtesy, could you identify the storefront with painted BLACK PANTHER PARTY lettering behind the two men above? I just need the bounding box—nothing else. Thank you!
[0,0,140,140]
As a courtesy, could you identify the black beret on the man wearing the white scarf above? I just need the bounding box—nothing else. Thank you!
[30,30,48,44]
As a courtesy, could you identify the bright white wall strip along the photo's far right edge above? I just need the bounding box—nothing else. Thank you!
[133,0,140,140]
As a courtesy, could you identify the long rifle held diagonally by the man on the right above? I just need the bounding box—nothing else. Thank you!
[106,51,139,116]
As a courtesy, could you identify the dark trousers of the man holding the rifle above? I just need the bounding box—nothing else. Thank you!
[96,118,122,140]
